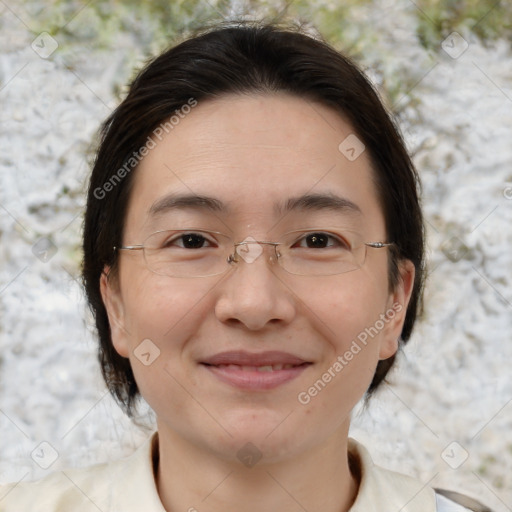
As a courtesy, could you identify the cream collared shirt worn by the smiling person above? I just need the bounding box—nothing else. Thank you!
[0,432,468,512]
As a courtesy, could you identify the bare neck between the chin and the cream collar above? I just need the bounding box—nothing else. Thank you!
[156,428,358,512]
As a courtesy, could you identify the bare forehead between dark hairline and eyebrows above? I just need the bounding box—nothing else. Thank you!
[122,93,382,233]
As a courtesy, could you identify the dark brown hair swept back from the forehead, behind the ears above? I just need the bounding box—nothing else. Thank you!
[82,22,424,416]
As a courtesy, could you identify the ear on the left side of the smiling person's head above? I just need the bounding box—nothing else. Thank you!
[100,265,129,357]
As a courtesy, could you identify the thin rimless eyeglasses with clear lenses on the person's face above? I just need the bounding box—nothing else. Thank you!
[114,228,394,277]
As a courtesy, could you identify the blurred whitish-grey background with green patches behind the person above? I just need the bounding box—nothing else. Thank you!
[0,0,512,511]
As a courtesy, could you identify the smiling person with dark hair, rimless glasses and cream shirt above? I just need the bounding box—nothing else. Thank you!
[0,21,492,512]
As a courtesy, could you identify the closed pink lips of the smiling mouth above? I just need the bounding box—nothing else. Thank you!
[201,351,312,391]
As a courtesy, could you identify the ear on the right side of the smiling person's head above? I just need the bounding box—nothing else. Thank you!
[379,260,416,359]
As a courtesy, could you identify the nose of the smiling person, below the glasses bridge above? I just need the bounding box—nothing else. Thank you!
[215,239,296,330]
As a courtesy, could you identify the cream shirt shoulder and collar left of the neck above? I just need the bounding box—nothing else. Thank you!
[0,436,164,512]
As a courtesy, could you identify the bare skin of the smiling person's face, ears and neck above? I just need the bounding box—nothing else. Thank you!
[101,93,414,512]
